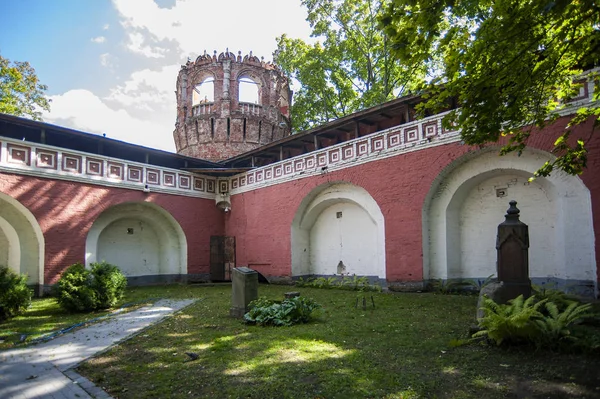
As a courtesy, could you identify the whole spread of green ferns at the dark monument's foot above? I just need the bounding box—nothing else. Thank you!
[473,295,593,349]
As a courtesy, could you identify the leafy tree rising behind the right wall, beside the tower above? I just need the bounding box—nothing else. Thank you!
[274,0,422,131]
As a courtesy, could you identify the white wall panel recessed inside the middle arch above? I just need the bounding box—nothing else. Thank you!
[310,202,379,276]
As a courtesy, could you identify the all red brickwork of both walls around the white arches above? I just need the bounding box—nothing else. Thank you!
[0,114,600,290]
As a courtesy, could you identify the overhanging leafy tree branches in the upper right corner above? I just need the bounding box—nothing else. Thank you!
[380,0,600,176]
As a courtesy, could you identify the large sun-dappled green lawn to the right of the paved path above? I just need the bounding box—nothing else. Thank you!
[69,285,600,398]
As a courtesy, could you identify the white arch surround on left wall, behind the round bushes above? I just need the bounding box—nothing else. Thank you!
[85,202,187,277]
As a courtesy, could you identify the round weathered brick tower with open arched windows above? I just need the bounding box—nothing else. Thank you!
[173,50,292,161]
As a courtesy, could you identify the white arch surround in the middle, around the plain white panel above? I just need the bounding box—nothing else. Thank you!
[291,182,386,279]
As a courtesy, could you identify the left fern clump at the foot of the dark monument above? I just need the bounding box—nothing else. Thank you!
[473,295,547,346]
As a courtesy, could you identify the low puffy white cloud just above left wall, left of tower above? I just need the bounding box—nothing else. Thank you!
[43,90,175,151]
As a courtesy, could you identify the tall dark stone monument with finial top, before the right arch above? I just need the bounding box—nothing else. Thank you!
[496,200,531,300]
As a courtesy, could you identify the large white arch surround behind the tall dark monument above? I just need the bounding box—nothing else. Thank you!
[423,148,597,294]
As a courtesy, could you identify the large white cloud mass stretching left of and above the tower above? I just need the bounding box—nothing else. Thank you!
[44,0,310,155]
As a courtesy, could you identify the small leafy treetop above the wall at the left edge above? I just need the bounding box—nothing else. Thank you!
[0,56,50,120]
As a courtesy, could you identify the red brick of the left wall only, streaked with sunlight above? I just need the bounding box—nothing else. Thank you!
[0,174,223,284]
